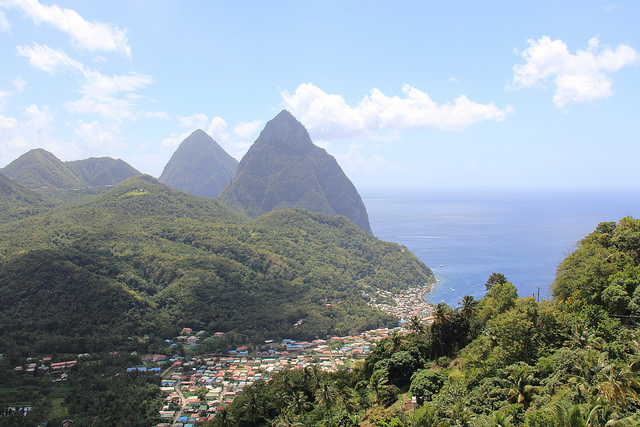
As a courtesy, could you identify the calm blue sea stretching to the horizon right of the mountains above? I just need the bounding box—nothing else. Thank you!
[363,190,640,307]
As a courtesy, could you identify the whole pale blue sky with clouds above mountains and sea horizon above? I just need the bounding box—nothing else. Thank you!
[0,0,640,191]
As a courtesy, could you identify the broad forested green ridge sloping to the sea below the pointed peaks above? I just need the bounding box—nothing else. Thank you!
[0,176,433,354]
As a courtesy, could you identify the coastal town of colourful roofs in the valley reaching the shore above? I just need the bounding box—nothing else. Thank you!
[10,287,433,427]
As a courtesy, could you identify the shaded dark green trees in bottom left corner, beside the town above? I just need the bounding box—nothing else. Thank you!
[0,354,163,427]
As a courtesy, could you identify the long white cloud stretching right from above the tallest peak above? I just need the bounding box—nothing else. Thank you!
[281,83,511,139]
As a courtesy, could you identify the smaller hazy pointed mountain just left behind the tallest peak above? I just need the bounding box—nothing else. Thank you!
[159,129,238,199]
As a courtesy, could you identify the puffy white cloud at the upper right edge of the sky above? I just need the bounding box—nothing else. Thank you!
[513,36,640,108]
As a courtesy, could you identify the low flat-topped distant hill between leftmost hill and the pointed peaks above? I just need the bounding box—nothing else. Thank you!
[65,157,140,187]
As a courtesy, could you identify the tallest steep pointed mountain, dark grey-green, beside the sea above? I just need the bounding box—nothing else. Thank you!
[220,110,371,233]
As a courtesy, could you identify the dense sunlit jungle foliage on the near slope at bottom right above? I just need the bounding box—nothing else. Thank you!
[214,217,640,427]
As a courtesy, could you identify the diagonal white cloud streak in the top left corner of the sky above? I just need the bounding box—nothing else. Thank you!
[2,0,131,58]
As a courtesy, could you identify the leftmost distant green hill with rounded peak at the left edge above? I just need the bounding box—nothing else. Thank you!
[0,148,88,189]
